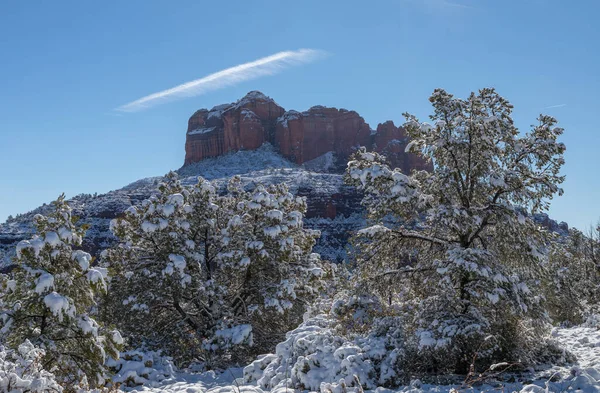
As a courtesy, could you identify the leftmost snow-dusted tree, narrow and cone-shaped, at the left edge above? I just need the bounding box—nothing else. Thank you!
[0,195,121,386]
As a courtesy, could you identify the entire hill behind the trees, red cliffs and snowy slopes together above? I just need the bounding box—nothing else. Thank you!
[0,92,568,265]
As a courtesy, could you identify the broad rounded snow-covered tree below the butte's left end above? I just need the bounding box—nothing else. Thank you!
[104,173,323,365]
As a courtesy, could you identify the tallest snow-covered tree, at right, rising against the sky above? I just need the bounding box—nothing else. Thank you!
[347,88,565,373]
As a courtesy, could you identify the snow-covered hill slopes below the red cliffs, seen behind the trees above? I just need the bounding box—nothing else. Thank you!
[0,144,364,266]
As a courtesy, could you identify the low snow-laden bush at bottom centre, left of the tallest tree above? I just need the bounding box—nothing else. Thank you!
[244,314,404,391]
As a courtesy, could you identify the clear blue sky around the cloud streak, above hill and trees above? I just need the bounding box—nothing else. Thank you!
[0,0,600,228]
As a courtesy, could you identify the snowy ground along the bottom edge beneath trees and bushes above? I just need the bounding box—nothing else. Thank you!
[123,327,600,393]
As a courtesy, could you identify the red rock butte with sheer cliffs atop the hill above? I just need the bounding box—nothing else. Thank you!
[185,91,431,173]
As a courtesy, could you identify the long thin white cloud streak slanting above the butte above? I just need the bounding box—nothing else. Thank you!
[116,49,327,112]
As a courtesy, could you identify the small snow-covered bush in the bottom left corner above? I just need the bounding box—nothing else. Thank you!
[0,340,63,393]
